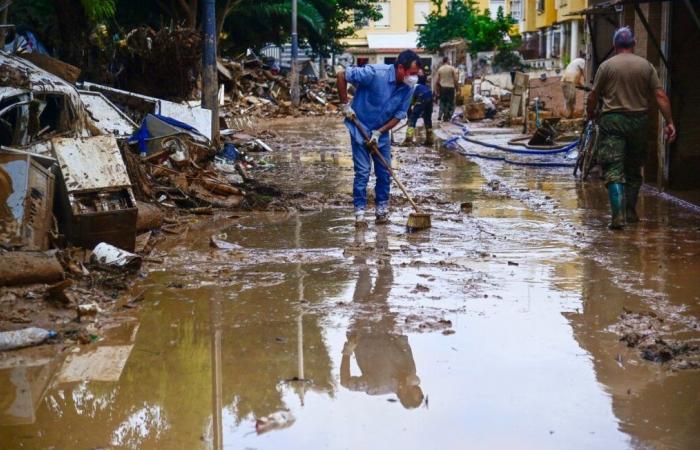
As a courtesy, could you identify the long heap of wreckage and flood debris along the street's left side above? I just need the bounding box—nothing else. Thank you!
[0,39,336,343]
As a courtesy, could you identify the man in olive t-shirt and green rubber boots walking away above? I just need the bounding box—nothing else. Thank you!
[586,27,676,229]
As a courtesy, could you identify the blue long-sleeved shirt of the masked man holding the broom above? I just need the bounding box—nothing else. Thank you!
[345,64,412,143]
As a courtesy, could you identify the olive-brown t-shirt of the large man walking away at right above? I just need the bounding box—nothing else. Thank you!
[593,53,661,113]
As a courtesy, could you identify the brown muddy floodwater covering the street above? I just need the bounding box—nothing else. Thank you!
[0,120,700,449]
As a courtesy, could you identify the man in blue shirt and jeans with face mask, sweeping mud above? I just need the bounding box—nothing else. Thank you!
[338,50,420,226]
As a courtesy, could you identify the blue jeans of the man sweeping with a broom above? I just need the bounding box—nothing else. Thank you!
[351,133,391,210]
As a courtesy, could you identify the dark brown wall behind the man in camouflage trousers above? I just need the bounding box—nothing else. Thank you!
[586,1,700,202]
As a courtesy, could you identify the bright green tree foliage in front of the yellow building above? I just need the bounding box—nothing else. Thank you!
[418,0,516,54]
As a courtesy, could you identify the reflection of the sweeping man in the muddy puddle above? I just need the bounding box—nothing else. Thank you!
[340,227,423,408]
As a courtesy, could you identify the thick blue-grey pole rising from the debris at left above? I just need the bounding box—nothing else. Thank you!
[202,0,219,143]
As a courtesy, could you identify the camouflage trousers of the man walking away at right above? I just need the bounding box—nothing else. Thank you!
[598,112,649,188]
